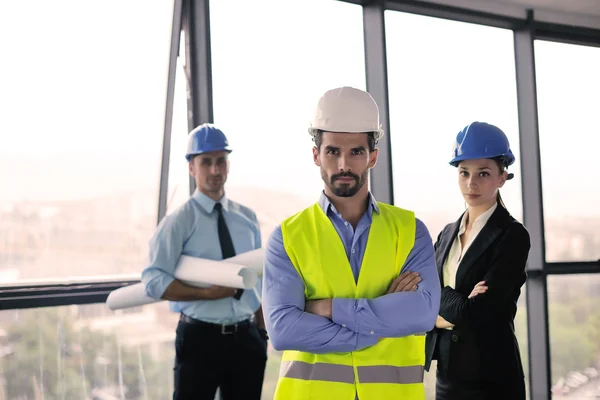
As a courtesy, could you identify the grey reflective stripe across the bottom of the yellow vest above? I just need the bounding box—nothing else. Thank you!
[280,361,425,384]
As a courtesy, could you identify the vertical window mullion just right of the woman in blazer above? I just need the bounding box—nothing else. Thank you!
[514,21,551,400]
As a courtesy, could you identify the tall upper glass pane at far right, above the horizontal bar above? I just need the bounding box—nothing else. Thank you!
[535,40,600,262]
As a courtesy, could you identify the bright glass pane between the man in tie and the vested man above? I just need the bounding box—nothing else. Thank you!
[211,0,365,399]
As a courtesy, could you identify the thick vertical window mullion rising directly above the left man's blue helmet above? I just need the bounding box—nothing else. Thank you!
[182,0,213,194]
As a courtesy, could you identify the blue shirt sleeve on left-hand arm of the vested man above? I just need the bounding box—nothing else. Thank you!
[263,226,378,353]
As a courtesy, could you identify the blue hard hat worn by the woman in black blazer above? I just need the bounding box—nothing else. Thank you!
[450,122,515,167]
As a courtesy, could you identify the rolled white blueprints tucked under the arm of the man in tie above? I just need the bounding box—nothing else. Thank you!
[106,248,264,310]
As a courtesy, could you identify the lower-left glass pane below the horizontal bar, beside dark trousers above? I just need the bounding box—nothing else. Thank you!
[0,302,178,400]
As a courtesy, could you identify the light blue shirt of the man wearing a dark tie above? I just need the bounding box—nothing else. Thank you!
[142,189,262,324]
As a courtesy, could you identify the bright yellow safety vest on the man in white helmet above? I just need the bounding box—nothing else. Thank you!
[275,203,425,400]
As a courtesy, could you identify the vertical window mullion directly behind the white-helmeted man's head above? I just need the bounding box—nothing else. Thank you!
[363,0,394,204]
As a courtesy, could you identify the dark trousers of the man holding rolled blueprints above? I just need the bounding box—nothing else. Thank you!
[173,321,267,400]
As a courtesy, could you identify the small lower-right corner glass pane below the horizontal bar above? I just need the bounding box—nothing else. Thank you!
[548,274,600,399]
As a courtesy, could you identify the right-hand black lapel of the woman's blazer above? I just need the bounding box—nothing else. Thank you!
[456,205,510,288]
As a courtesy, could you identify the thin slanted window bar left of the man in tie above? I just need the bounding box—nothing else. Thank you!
[157,0,183,224]
